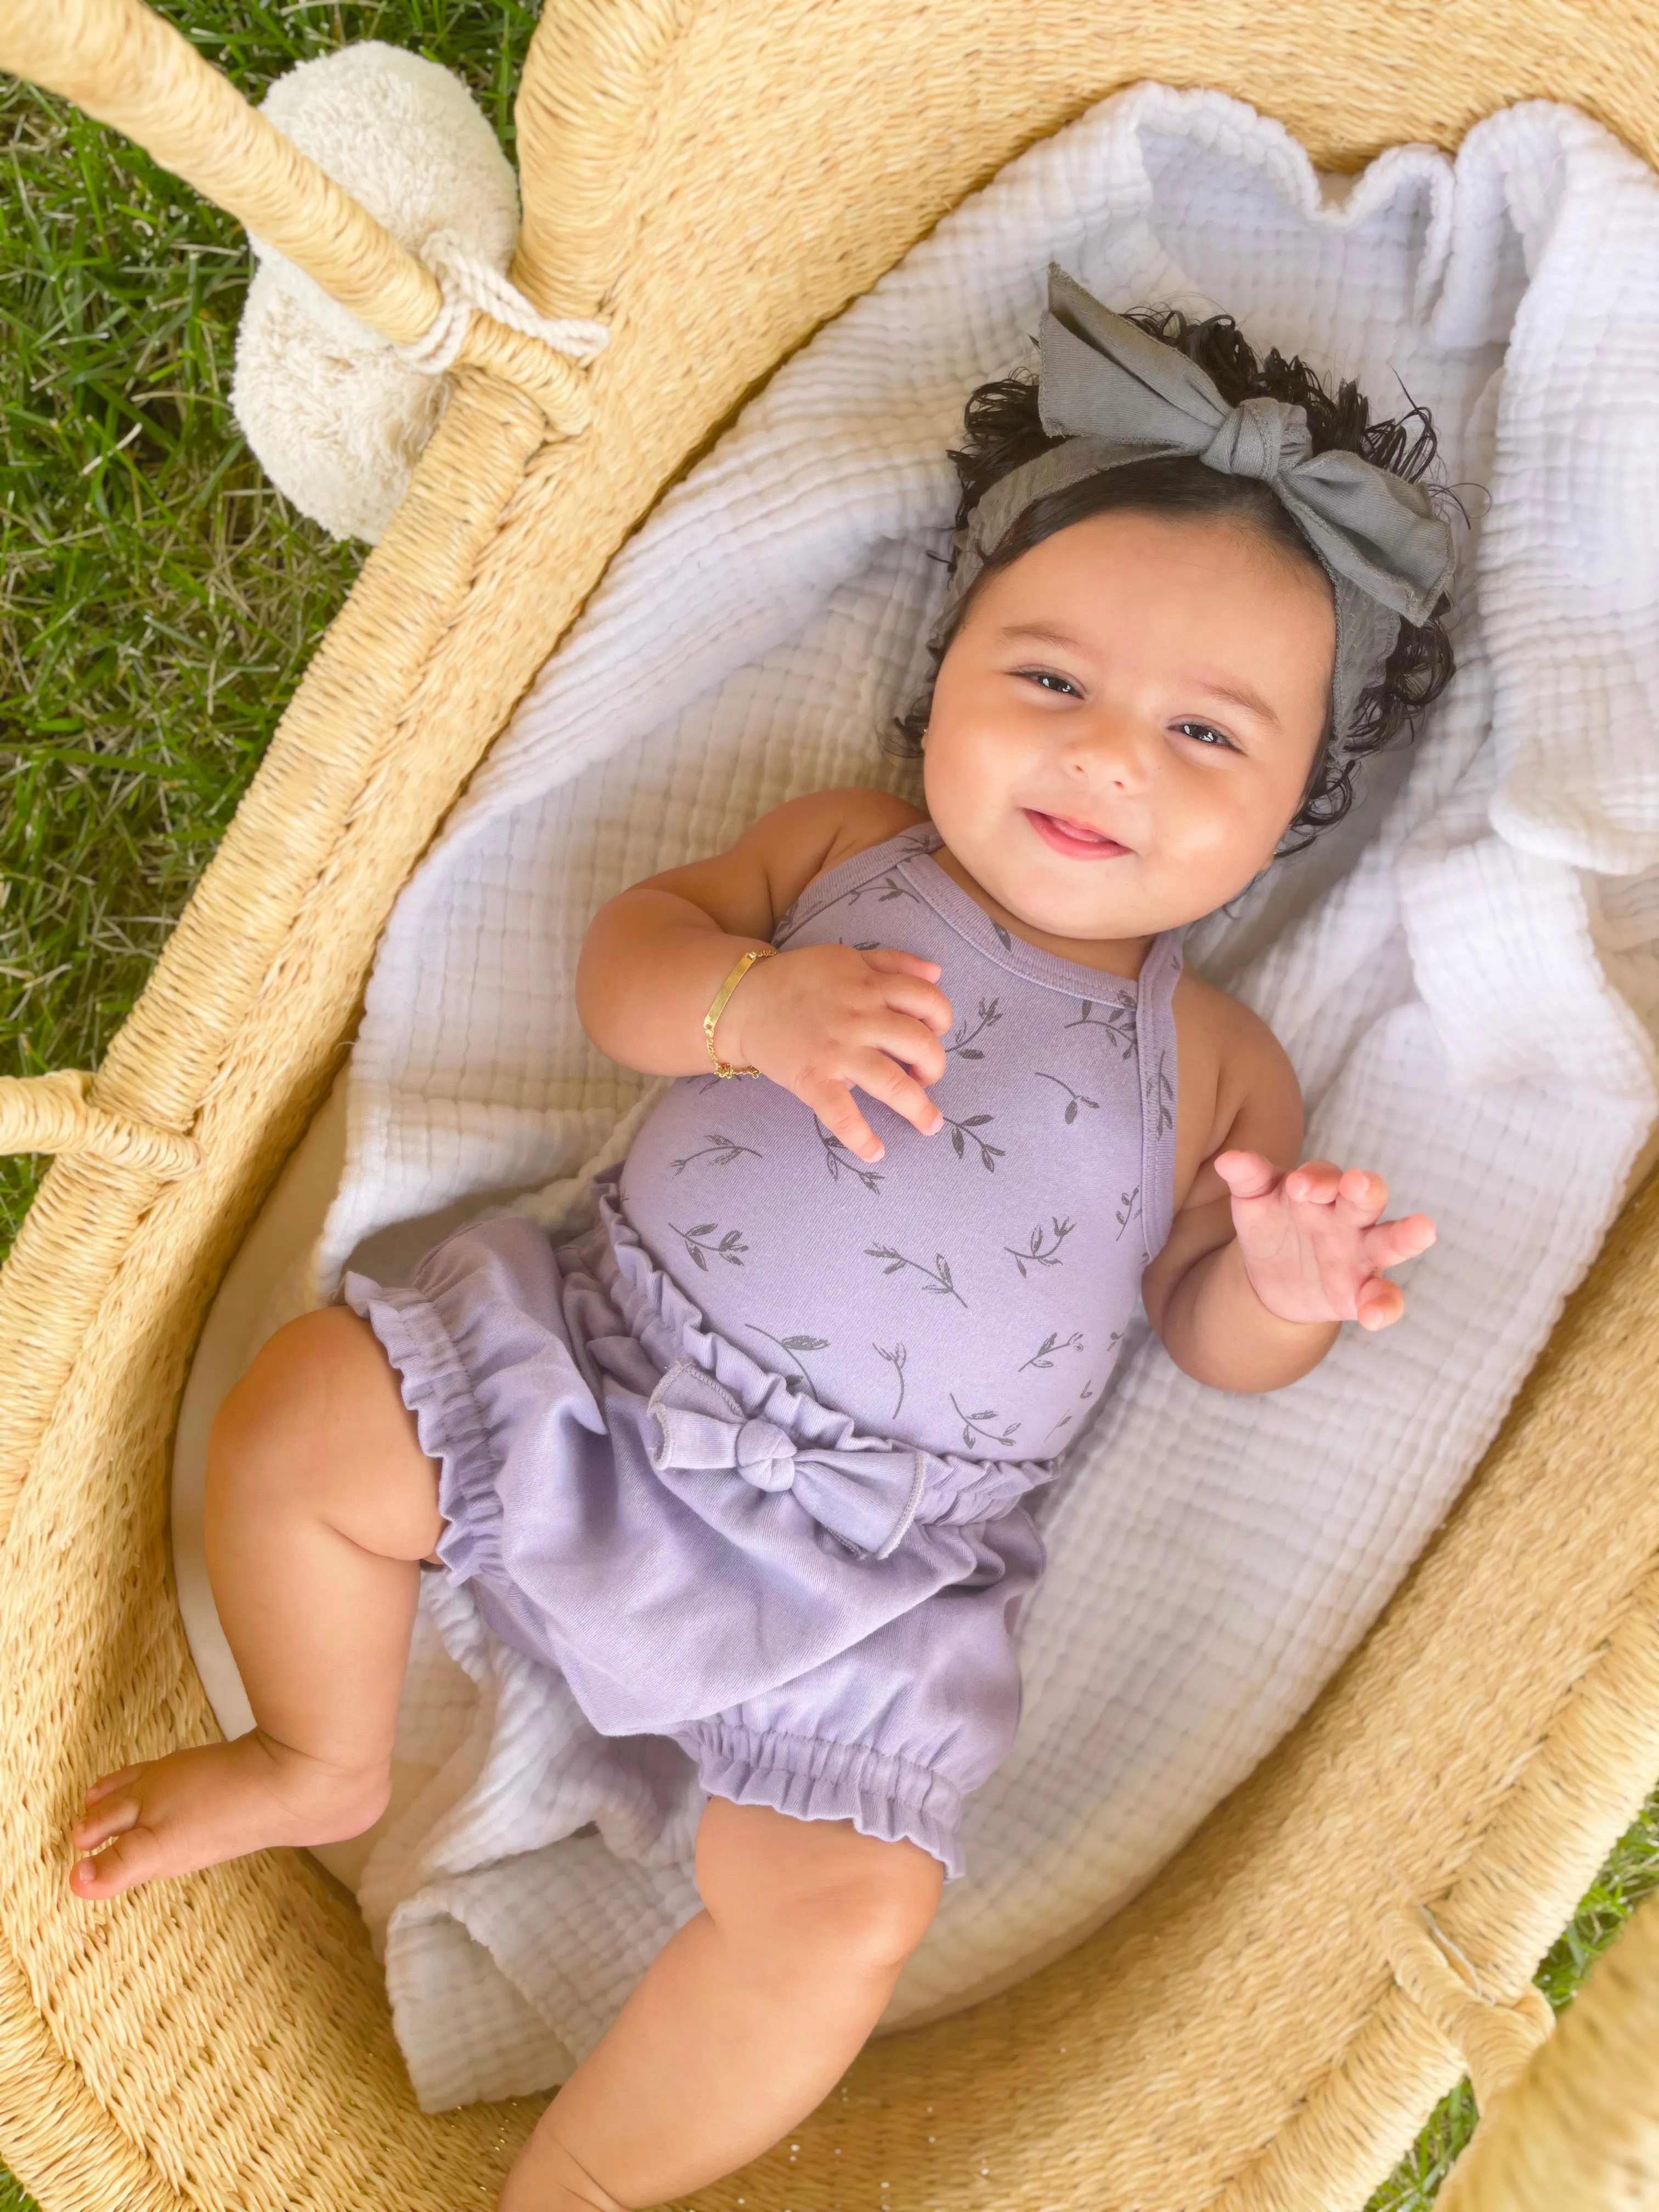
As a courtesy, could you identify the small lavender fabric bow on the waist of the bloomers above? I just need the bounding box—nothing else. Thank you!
[650,1361,931,1560]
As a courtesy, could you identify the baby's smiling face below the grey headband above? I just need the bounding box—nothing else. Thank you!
[922,513,1336,943]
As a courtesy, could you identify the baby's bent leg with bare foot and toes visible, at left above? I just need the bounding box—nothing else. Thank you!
[71,1307,442,1898]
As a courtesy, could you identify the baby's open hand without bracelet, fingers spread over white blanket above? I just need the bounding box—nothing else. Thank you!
[1215,1153,1434,1329]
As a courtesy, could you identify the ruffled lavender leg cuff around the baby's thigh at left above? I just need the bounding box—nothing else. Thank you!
[341,1274,509,1584]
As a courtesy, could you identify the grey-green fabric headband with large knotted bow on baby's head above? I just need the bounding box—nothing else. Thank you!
[934,266,1455,735]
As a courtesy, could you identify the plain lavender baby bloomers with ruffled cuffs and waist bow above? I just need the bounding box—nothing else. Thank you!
[343,1179,1053,1876]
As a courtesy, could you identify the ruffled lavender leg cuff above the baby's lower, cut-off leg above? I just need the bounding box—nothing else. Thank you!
[675,1721,967,1882]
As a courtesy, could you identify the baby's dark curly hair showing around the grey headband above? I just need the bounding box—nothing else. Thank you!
[887,307,1453,851]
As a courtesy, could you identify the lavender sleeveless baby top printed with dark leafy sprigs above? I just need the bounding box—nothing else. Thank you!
[622,825,1179,1460]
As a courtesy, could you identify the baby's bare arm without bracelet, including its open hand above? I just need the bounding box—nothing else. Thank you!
[1142,993,1434,1391]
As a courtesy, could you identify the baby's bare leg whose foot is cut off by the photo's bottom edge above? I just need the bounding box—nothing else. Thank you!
[500,1798,943,2212]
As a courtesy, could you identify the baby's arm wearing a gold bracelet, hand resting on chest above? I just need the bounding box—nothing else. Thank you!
[575,789,951,1159]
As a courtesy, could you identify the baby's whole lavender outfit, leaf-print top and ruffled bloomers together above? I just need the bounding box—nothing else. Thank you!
[345,825,1179,1876]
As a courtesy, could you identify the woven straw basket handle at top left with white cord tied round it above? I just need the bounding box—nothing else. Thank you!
[0,0,589,436]
